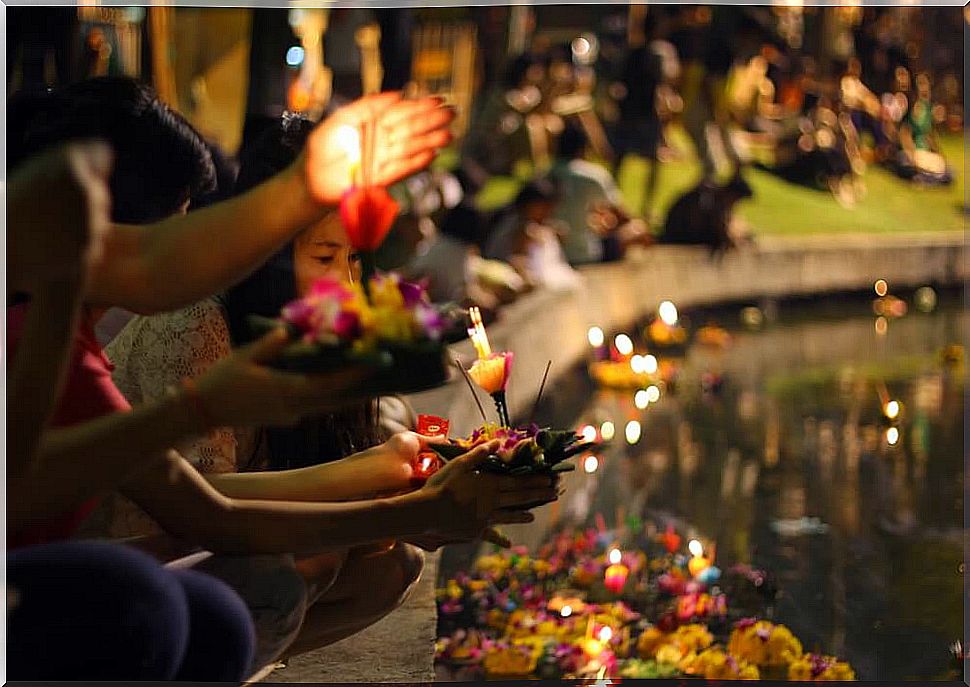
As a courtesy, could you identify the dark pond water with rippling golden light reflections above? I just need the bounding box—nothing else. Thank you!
[442,297,967,680]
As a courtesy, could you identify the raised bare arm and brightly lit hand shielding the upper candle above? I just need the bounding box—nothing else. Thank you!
[88,93,454,314]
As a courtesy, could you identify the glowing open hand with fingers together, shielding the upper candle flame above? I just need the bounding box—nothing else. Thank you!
[297,92,455,205]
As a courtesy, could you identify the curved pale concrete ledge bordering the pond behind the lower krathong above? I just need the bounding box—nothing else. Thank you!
[409,231,968,433]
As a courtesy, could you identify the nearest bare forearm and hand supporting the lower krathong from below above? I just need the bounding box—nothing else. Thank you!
[122,443,544,554]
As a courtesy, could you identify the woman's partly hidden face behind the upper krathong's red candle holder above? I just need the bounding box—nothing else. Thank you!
[293,213,360,296]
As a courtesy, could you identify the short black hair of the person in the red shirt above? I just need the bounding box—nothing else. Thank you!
[7,77,215,224]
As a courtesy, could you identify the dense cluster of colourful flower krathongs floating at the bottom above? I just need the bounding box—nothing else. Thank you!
[436,528,854,681]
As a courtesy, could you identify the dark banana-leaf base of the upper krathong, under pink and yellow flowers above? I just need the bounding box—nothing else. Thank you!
[248,315,451,396]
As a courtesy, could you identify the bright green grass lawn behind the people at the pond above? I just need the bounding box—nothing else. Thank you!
[466,132,964,235]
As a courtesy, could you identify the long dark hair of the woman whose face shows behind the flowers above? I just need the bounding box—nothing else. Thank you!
[221,114,382,470]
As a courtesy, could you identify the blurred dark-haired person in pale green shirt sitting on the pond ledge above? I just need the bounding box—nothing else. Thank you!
[549,126,652,265]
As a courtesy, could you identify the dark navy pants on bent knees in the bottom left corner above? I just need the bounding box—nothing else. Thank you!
[7,542,255,682]
